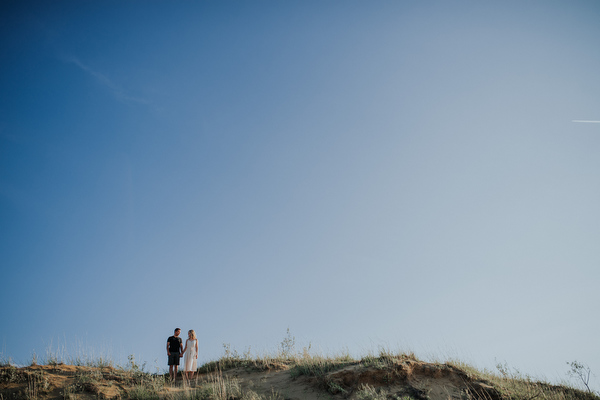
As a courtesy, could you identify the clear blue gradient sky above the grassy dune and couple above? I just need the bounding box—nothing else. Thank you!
[0,0,600,387]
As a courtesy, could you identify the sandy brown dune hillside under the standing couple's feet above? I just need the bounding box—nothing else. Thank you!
[0,358,598,400]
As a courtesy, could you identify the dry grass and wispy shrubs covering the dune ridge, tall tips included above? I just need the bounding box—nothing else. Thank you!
[0,336,600,400]
